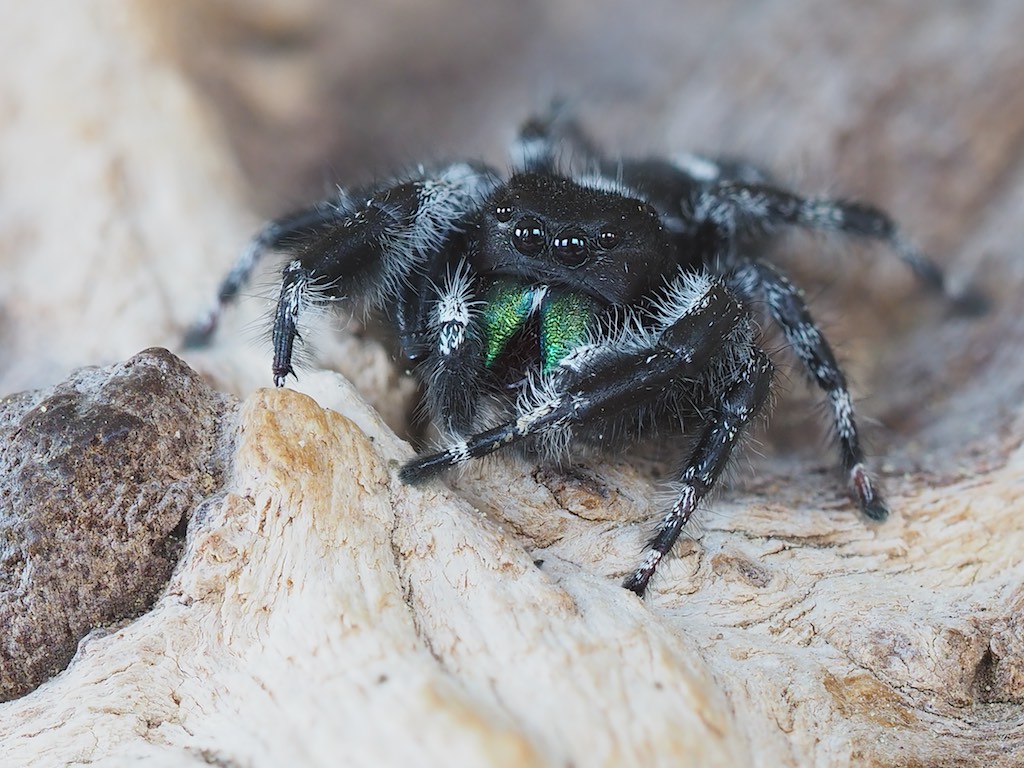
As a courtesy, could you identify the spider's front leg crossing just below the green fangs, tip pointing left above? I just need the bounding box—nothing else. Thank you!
[399,281,744,483]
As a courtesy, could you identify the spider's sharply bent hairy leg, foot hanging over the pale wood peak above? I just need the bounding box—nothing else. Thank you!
[272,163,499,386]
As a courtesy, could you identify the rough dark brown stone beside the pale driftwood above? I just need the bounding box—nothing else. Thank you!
[0,349,232,700]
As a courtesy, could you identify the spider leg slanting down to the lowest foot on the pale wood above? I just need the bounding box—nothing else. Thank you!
[623,347,773,597]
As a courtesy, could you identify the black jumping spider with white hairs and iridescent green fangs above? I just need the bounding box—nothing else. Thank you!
[189,116,980,595]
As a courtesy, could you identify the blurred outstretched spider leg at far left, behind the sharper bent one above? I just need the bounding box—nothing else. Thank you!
[184,198,350,348]
